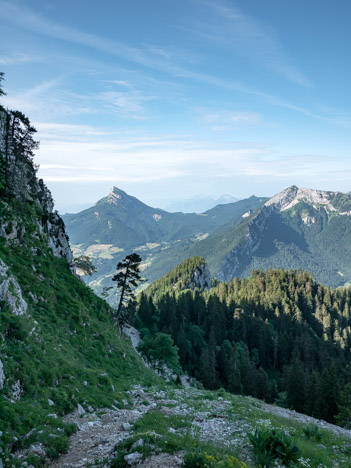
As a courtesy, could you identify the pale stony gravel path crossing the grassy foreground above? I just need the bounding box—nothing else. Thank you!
[50,386,351,468]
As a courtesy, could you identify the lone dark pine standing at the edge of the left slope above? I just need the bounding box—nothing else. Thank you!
[112,253,142,324]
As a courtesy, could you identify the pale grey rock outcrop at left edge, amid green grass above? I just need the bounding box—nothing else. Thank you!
[0,259,28,315]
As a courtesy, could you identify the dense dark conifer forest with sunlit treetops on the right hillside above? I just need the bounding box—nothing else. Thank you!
[138,258,351,427]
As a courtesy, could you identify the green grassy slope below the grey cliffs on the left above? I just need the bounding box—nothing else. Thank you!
[0,197,155,465]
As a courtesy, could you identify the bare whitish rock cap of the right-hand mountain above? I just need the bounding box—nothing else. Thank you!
[266,185,339,211]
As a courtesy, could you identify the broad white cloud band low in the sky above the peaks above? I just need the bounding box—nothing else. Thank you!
[31,124,351,186]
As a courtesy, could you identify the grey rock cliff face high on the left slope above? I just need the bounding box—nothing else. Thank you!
[0,110,73,263]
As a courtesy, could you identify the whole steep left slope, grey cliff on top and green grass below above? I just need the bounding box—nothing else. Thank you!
[0,107,156,467]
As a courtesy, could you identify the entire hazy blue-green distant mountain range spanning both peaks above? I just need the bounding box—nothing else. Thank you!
[63,186,351,298]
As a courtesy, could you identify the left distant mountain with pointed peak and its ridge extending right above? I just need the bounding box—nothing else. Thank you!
[63,187,267,298]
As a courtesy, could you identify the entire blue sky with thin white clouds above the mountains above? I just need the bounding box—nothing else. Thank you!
[0,0,351,212]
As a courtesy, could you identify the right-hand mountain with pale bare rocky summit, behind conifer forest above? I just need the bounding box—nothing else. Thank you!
[202,186,351,286]
